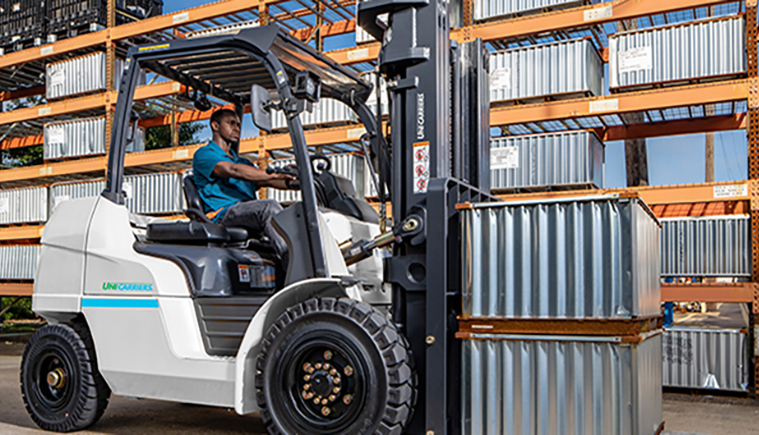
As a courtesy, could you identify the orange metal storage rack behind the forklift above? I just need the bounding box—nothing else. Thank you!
[0,0,759,394]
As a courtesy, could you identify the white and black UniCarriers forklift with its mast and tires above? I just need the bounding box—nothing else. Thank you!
[21,0,494,435]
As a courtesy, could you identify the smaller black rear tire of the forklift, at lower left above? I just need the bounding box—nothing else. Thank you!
[21,324,111,432]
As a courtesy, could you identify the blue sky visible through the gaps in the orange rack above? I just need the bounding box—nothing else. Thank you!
[164,0,748,187]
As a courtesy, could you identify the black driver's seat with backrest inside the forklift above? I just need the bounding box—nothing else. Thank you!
[146,174,250,245]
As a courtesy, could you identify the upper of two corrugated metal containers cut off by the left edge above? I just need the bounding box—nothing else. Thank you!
[0,187,47,225]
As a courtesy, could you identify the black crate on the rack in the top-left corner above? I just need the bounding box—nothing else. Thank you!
[0,0,45,54]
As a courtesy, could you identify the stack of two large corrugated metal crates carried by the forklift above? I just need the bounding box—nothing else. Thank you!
[457,196,662,435]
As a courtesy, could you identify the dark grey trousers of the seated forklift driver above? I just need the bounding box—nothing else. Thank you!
[221,199,289,267]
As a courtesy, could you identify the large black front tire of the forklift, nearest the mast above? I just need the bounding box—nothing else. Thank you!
[256,298,416,435]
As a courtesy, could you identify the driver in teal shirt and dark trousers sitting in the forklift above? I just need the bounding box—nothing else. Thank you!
[192,109,293,269]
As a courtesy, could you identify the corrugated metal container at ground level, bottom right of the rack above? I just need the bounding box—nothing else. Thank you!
[662,326,749,391]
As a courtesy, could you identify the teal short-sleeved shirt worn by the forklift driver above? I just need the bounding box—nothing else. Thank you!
[192,141,258,222]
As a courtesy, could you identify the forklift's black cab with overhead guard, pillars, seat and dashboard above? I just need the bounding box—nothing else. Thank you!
[103,26,382,295]
